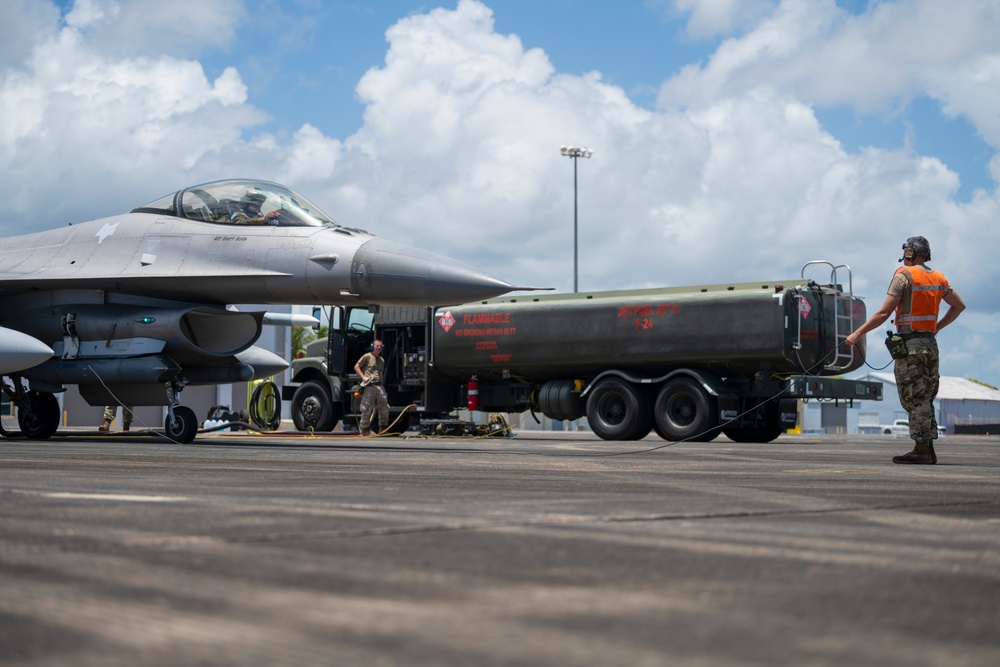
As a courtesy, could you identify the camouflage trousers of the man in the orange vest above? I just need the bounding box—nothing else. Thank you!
[896,337,940,441]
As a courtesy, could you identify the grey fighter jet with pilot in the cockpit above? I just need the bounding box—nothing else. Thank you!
[0,180,531,443]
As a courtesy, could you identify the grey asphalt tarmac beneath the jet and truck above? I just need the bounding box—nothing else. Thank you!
[0,433,1000,667]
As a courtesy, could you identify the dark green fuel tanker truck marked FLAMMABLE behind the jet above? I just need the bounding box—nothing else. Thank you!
[282,261,882,442]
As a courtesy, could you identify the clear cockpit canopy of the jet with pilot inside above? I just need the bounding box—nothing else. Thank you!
[132,179,337,227]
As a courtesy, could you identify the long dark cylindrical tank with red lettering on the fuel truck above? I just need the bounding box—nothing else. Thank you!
[431,279,866,382]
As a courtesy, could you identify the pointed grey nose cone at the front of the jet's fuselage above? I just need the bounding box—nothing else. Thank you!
[351,239,515,306]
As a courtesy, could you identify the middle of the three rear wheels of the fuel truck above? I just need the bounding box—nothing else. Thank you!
[653,378,719,442]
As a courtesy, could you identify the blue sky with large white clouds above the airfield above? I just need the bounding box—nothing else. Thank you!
[0,0,1000,386]
